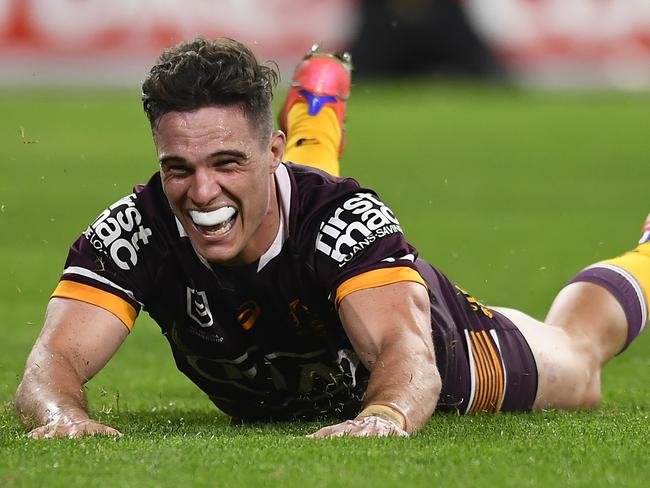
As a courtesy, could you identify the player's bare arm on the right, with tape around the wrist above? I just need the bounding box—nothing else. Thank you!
[312,281,442,437]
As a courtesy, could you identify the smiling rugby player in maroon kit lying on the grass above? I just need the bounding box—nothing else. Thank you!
[15,39,650,438]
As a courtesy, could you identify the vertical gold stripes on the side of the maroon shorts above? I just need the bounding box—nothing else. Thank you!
[467,330,505,413]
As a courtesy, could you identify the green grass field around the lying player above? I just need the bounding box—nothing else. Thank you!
[0,82,650,487]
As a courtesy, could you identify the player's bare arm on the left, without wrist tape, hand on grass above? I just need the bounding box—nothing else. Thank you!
[14,298,128,438]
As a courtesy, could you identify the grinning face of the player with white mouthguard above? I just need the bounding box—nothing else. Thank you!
[154,106,285,266]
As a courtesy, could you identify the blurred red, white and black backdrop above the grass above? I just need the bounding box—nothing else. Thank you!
[0,0,650,89]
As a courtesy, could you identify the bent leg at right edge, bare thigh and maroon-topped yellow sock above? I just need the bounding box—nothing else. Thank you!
[497,216,650,409]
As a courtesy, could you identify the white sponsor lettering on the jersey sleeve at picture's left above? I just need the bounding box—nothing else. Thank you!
[84,193,151,270]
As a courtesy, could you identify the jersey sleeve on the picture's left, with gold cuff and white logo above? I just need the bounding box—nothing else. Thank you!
[52,194,152,330]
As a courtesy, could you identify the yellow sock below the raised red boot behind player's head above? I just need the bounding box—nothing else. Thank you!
[284,103,343,176]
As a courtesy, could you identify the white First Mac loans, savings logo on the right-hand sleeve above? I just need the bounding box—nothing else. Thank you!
[316,193,402,267]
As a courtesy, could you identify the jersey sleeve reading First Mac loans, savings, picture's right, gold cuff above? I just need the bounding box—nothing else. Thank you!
[314,190,426,306]
